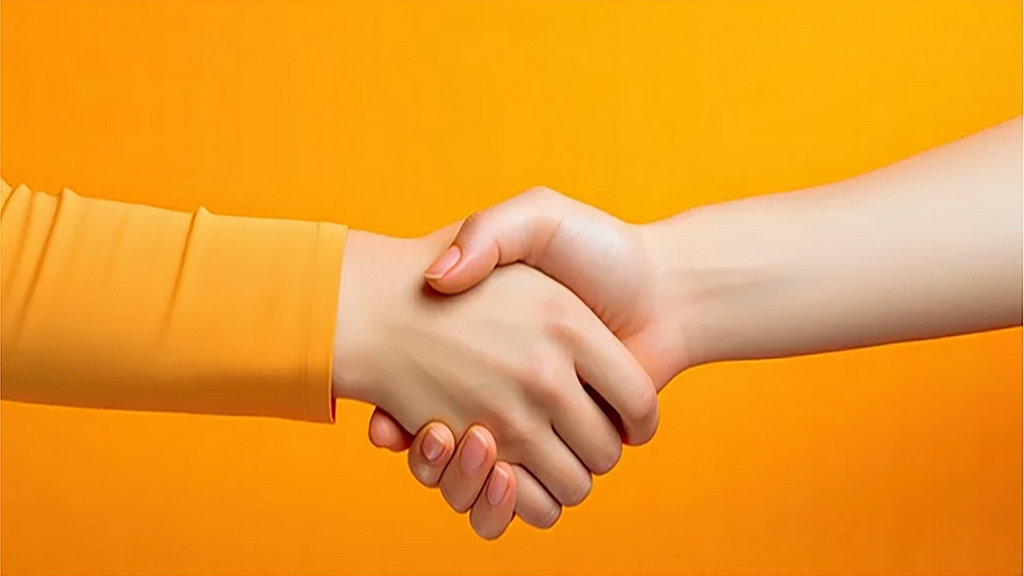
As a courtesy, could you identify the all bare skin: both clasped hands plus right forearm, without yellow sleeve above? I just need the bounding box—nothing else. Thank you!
[333,121,1022,538]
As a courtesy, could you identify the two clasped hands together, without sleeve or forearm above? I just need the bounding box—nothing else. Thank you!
[334,189,679,538]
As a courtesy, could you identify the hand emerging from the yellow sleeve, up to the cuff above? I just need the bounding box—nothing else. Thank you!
[334,224,657,524]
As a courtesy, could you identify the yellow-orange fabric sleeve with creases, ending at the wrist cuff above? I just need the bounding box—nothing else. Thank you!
[0,182,346,422]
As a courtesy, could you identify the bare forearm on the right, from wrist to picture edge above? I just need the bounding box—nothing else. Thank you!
[649,119,1022,364]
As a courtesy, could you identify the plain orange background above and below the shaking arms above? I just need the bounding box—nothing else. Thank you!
[0,2,1024,573]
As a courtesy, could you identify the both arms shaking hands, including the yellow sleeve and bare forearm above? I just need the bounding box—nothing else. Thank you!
[0,118,1011,538]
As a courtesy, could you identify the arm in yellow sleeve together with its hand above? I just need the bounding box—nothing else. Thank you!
[0,178,657,526]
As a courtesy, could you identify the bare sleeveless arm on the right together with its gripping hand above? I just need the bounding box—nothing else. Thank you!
[371,118,1024,538]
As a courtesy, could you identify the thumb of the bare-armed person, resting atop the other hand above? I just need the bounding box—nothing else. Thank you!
[423,188,562,294]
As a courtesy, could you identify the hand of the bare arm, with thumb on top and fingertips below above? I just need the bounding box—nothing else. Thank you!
[370,188,692,536]
